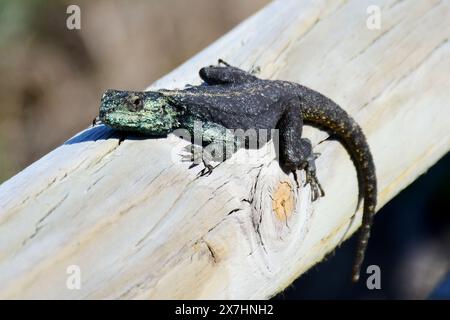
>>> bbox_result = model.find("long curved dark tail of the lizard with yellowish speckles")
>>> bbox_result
[302,96,377,282]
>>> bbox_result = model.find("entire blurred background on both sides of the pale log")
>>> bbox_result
[0,0,450,299]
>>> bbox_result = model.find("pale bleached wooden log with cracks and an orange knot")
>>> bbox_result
[0,0,450,299]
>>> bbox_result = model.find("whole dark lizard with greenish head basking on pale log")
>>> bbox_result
[99,59,377,282]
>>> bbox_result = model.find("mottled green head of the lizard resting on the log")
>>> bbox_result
[100,90,179,136]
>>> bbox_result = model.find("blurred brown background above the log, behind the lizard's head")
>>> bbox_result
[0,0,269,182]
